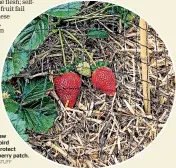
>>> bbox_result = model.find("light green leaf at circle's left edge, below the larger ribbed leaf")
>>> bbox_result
[2,51,29,81]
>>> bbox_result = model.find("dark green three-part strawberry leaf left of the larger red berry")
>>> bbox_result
[2,78,56,135]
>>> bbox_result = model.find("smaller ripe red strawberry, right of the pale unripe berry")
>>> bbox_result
[92,67,116,96]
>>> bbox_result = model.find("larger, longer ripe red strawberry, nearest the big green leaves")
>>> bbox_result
[54,72,81,108]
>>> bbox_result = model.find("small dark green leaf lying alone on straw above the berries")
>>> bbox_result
[88,28,109,39]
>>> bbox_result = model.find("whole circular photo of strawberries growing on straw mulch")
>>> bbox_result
[1,1,175,168]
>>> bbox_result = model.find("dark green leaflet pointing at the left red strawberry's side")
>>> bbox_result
[22,78,53,103]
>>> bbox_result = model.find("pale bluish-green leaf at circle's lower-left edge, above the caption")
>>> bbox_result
[7,112,29,141]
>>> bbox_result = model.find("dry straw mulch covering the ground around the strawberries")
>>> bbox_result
[2,1,175,167]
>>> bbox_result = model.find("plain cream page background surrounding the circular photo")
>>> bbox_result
[0,0,176,168]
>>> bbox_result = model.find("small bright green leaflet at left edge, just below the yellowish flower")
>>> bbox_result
[4,98,19,113]
